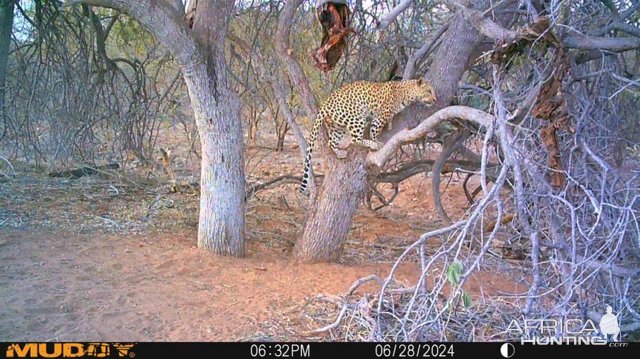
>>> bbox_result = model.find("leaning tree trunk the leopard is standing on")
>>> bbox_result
[294,14,481,262]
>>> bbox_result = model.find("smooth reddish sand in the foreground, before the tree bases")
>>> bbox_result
[0,230,523,341]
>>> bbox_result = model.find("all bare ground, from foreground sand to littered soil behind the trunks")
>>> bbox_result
[0,128,527,341]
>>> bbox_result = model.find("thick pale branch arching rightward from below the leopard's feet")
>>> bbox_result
[367,106,495,168]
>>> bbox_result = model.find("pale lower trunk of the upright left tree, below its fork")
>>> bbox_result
[184,60,245,257]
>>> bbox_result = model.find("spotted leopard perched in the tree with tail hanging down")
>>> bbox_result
[300,79,437,193]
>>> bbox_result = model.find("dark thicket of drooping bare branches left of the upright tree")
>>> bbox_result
[3,2,188,168]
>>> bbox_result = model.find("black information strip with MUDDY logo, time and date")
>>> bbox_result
[0,342,640,359]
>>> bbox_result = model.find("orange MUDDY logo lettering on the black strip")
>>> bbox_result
[6,343,135,358]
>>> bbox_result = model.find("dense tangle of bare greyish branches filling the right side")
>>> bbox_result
[323,1,640,341]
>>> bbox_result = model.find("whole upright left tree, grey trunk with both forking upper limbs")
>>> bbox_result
[78,0,245,257]
